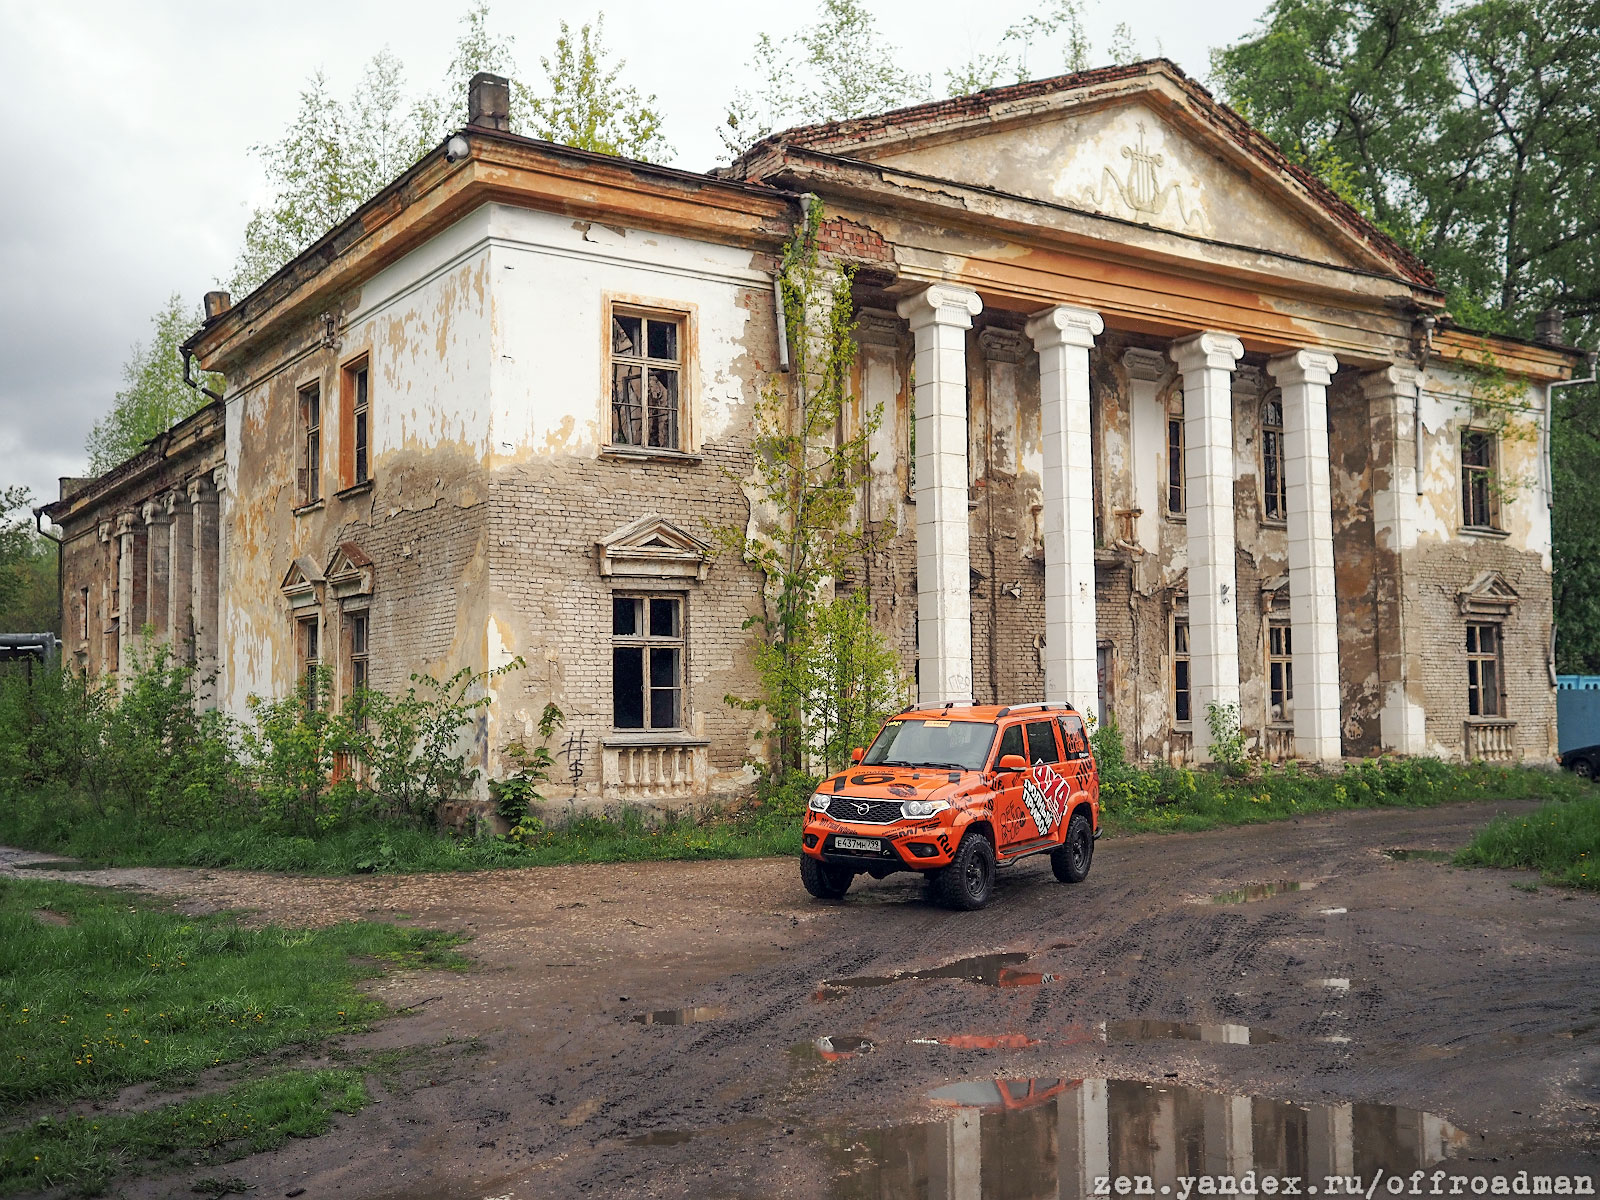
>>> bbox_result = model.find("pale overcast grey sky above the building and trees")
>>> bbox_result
[0,0,1266,512]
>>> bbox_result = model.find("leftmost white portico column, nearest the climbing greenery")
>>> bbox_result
[898,283,984,704]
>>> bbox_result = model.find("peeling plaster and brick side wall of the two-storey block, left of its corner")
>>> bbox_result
[222,210,491,715]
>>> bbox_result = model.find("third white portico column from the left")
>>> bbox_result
[1171,331,1245,762]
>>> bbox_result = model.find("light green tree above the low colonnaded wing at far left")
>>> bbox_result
[83,291,219,475]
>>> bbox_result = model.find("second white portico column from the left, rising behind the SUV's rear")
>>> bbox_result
[1027,304,1106,712]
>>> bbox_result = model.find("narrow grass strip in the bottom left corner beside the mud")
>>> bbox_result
[0,1070,370,1195]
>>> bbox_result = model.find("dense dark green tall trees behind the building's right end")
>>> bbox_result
[1213,0,1600,672]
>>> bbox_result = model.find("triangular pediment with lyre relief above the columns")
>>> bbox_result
[747,59,1432,285]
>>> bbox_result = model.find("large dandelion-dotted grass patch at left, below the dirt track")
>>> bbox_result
[0,878,466,1122]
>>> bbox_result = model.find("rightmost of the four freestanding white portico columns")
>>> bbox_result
[1267,350,1342,762]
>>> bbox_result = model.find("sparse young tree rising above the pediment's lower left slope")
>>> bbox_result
[722,0,930,155]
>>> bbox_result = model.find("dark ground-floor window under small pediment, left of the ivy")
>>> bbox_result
[611,595,683,730]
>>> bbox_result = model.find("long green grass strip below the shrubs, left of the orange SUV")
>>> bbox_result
[0,794,800,875]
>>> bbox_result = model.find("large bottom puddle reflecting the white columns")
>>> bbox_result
[826,1078,1467,1200]
